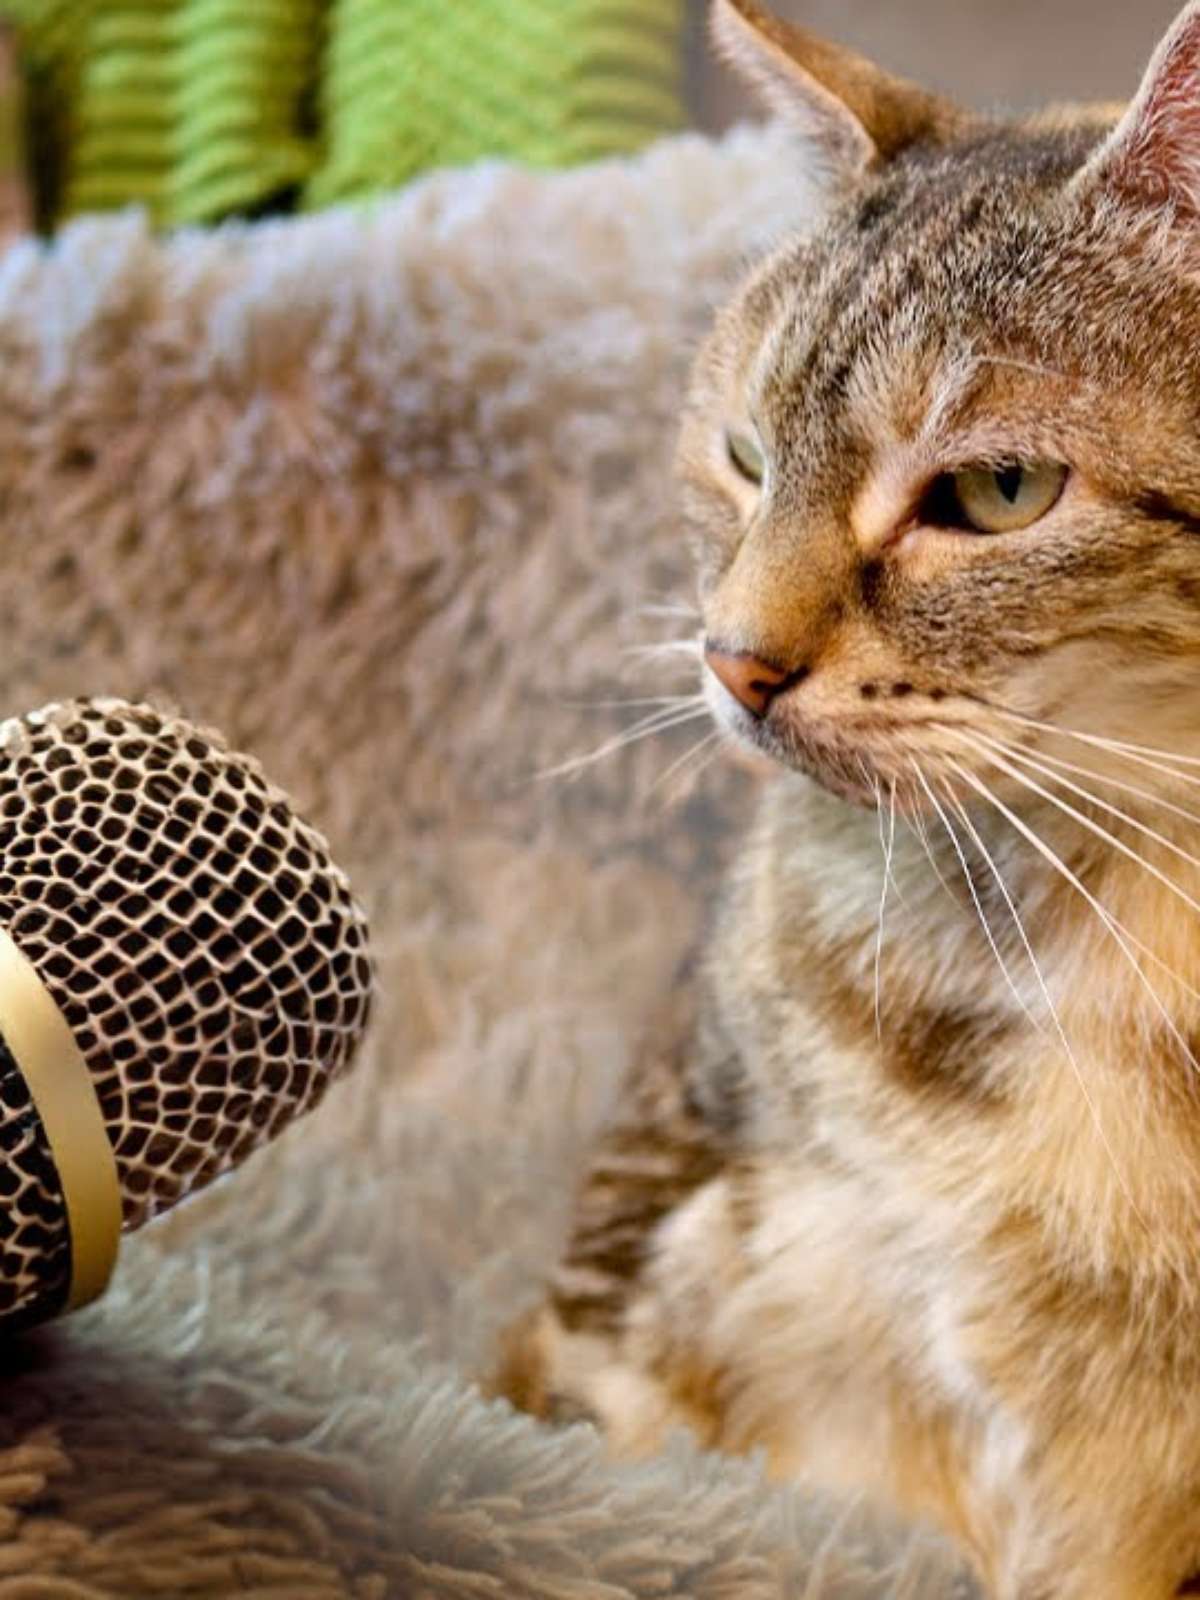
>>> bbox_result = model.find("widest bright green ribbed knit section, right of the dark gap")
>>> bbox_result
[306,0,683,205]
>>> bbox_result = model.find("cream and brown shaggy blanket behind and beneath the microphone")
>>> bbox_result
[0,131,979,1600]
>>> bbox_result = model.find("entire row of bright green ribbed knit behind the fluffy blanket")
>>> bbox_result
[3,0,683,224]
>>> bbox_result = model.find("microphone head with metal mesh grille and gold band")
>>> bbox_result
[0,699,373,1334]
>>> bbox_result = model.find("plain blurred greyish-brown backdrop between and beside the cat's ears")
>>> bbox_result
[686,0,1182,130]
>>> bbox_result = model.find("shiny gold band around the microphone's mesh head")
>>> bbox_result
[0,928,122,1310]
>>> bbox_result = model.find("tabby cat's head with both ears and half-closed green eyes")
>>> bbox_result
[680,0,1200,802]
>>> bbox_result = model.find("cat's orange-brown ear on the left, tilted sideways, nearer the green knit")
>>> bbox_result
[710,0,970,174]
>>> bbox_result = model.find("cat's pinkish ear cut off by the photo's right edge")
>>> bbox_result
[1075,0,1200,219]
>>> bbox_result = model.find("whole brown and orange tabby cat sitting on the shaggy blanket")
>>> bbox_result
[498,0,1200,1600]
